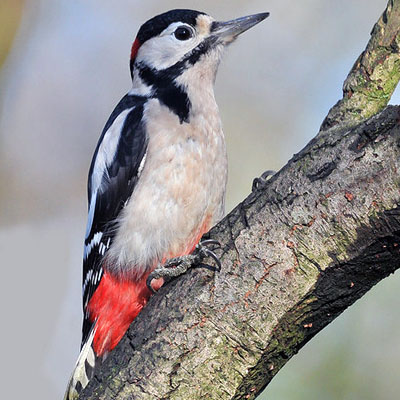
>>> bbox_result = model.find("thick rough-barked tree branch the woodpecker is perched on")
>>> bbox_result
[80,0,400,400]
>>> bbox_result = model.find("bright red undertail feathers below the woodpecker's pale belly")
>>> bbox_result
[88,272,156,356]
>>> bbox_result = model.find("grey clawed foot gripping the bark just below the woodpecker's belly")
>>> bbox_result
[146,239,221,293]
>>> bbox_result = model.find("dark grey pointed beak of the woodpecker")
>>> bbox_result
[211,13,269,43]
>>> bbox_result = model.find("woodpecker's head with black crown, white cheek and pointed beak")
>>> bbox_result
[130,10,269,83]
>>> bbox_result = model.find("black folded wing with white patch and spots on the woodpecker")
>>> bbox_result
[82,95,148,345]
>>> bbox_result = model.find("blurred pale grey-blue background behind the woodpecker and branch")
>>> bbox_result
[0,0,400,400]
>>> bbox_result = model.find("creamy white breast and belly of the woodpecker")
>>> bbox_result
[107,100,227,278]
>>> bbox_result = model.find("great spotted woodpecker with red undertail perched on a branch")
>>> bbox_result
[65,10,268,399]
